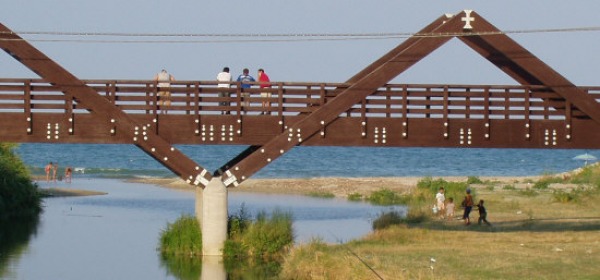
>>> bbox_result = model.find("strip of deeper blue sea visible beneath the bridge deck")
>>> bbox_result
[16,144,600,178]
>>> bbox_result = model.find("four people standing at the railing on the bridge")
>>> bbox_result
[154,67,271,114]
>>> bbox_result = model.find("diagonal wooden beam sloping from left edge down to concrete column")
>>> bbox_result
[0,24,212,186]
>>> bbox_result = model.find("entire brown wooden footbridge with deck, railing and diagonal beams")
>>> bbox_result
[0,11,600,190]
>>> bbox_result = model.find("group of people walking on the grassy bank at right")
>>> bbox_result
[433,187,491,226]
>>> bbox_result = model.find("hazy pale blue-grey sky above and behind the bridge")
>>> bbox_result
[0,0,600,86]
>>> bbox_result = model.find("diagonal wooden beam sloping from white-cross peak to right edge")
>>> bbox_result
[459,12,600,123]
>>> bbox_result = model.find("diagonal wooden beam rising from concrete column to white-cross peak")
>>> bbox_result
[222,12,463,186]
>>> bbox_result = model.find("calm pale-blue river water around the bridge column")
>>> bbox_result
[0,178,404,280]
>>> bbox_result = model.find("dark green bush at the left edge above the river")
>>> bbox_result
[0,143,42,219]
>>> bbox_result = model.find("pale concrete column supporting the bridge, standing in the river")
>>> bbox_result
[202,177,227,256]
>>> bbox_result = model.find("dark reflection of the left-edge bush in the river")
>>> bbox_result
[0,215,40,278]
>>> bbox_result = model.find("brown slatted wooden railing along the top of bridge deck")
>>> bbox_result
[0,79,600,120]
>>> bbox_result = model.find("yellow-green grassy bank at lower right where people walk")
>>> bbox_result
[281,172,600,279]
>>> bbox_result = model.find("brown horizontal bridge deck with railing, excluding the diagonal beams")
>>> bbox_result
[0,79,600,148]
